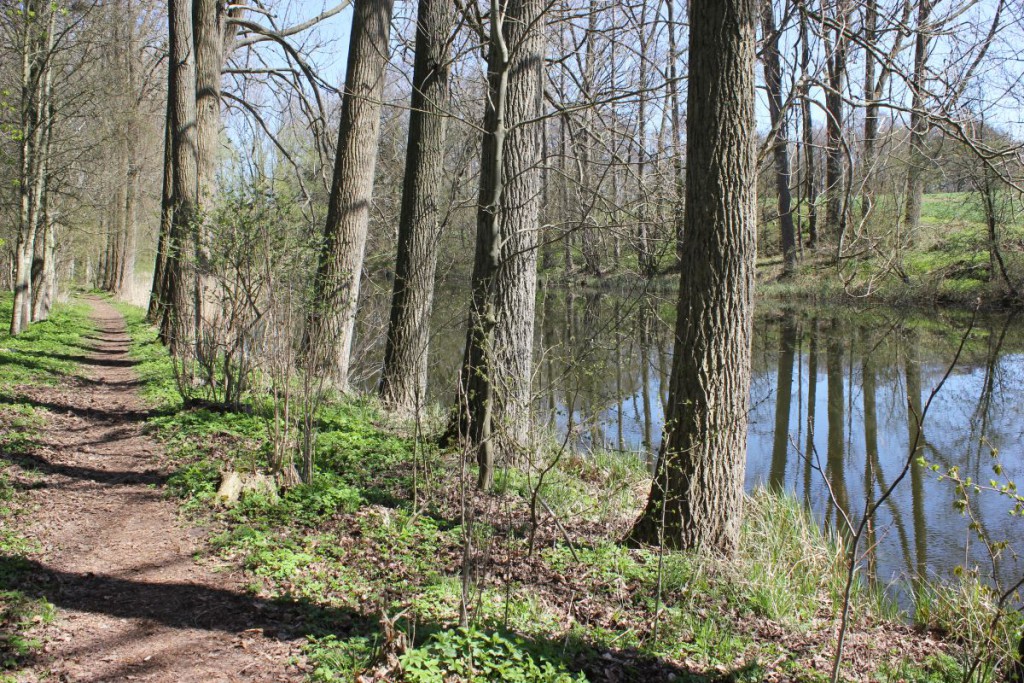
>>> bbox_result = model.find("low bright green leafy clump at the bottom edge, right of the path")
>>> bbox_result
[401,629,587,683]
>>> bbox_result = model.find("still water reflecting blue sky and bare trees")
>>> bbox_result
[352,291,1024,583]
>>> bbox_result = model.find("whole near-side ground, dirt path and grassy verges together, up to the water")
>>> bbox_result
[0,298,1017,683]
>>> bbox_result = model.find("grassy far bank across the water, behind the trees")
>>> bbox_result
[541,193,1024,310]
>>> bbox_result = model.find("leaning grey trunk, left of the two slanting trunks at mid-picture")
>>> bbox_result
[305,0,393,390]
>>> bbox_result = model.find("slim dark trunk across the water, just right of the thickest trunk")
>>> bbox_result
[761,0,797,275]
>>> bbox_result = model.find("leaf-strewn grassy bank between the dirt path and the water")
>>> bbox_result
[108,306,1013,683]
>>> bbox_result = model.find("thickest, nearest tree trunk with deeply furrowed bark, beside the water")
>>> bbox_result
[631,0,758,552]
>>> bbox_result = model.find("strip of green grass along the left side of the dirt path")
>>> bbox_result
[0,293,93,683]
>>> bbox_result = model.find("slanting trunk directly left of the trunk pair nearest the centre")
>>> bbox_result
[380,0,455,413]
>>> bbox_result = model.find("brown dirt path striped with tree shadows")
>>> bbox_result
[14,300,302,683]
